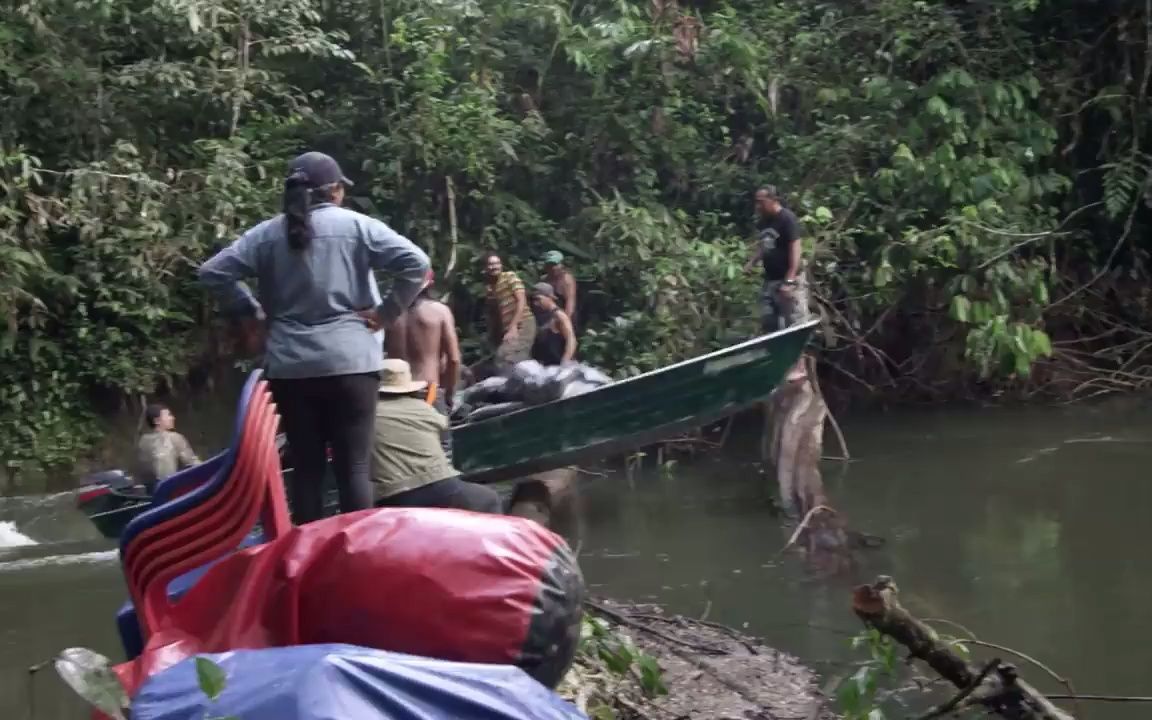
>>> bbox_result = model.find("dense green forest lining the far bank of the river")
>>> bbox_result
[0,0,1152,474]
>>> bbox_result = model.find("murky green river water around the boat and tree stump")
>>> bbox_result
[0,401,1152,720]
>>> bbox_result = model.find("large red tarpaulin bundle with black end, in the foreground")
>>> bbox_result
[108,508,584,697]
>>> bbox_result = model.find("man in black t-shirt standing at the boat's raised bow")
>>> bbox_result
[744,185,808,333]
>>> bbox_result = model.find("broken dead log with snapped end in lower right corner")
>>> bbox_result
[852,576,1075,720]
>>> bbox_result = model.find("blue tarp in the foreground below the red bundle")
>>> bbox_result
[131,645,586,720]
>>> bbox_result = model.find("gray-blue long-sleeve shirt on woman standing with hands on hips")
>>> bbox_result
[199,204,429,378]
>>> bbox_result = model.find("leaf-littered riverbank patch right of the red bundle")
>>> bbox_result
[560,599,835,720]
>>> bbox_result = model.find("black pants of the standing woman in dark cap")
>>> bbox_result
[270,372,380,524]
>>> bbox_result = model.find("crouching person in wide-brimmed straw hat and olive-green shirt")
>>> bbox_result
[372,357,503,514]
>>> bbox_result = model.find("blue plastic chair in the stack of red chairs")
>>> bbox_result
[116,370,274,660]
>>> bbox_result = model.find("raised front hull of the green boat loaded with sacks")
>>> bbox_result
[452,320,817,483]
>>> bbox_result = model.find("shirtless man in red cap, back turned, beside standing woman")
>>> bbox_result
[384,271,460,460]
